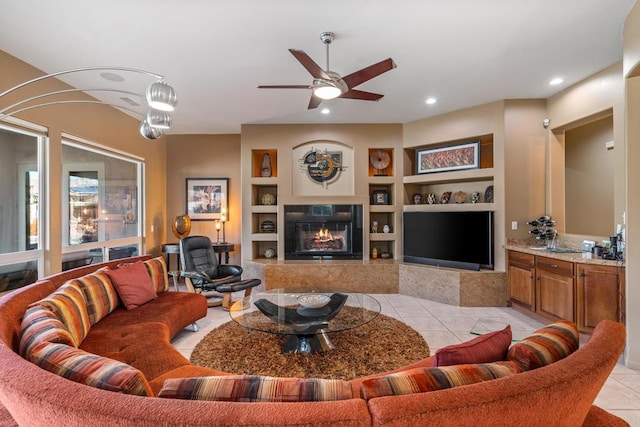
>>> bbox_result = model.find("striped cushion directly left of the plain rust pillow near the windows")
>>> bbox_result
[71,269,120,325]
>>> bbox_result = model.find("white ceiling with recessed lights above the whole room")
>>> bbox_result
[0,0,633,134]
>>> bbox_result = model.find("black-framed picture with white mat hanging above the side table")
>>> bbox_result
[185,178,229,221]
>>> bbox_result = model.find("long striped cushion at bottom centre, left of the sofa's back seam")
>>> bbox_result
[158,375,352,402]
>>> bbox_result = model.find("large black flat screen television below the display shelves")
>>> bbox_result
[402,211,493,270]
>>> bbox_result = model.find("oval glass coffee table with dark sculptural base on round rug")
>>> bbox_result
[229,289,380,354]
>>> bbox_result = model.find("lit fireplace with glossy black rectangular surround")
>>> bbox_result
[284,205,363,259]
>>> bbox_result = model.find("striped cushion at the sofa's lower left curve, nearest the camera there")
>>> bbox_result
[31,343,153,396]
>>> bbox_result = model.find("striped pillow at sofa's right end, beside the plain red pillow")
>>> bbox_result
[507,320,580,371]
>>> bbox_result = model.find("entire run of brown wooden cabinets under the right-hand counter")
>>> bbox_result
[507,250,625,333]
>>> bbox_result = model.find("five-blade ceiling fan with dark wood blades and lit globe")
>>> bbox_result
[258,31,396,110]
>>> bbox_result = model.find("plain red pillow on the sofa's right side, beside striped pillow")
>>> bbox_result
[435,325,512,366]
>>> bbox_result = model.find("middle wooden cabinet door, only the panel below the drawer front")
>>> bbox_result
[536,268,575,321]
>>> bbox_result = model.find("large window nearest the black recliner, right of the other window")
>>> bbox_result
[62,140,143,269]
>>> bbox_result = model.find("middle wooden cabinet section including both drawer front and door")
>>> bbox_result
[536,257,575,321]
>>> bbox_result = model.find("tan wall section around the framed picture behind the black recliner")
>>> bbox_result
[164,135,243,264]
